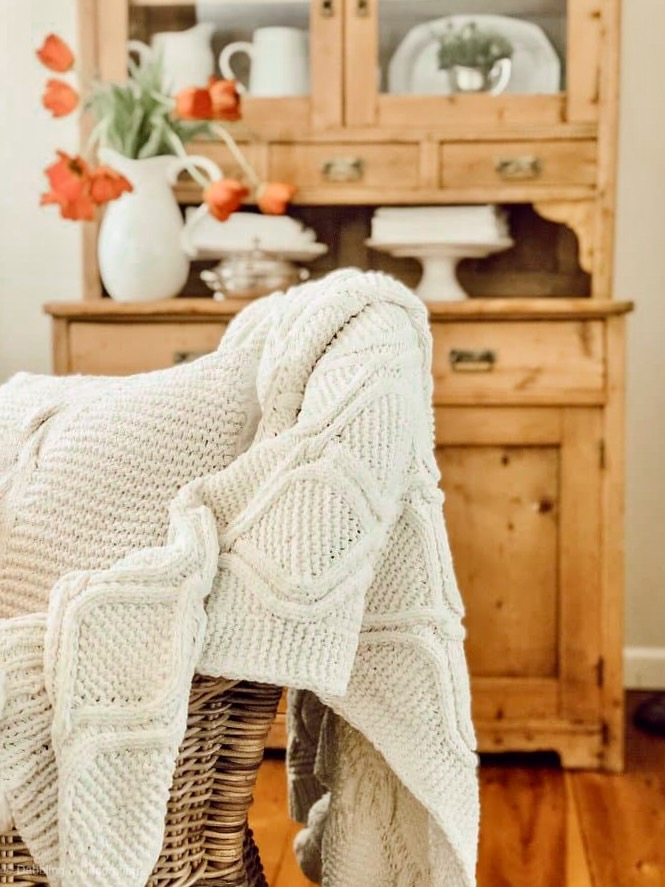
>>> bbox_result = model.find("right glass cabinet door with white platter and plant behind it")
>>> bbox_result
[346,0,614,126]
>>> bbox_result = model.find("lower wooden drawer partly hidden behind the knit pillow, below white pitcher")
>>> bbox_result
[68,322,227,376]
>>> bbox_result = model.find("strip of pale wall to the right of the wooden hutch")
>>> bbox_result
[615,0,665,688]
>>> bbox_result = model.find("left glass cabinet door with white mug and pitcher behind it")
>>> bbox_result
[97,0,342,135]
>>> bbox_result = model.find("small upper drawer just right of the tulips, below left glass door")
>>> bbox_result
[270,142,420,189]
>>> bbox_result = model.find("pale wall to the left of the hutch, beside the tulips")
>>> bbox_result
[0,0,82,380]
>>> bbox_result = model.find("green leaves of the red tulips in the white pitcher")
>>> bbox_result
[86,52,209,159]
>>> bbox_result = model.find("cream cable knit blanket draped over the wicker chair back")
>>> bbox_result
[0,271,478,887]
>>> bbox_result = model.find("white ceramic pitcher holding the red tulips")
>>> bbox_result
[97,148,221,302]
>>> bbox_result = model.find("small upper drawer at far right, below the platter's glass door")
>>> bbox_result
[441,141,597,188]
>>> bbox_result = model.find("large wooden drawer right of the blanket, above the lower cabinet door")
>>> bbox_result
[432,321,605,404]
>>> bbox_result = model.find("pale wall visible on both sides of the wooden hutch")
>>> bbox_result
[0,0,665,687]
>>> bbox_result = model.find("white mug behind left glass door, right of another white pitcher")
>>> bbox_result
[219,28,310,97]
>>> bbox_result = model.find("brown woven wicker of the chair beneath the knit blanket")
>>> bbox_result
[0,677,281,887]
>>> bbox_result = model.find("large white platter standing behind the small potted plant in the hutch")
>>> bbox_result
[388,15,561,95]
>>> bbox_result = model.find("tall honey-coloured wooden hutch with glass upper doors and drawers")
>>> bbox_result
[47,0,631,770]
